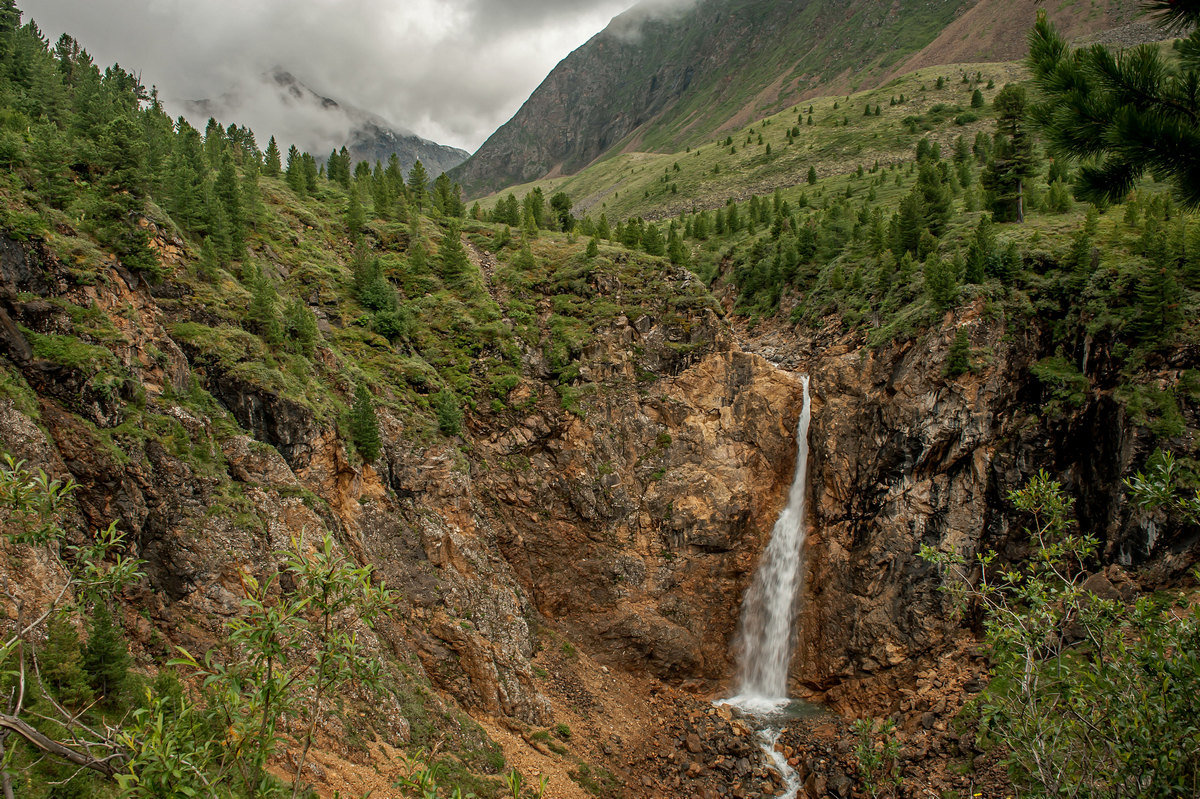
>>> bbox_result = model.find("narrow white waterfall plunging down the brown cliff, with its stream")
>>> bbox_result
[720,377,811,799]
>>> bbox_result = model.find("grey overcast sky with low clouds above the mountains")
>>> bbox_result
[18,0,635,151]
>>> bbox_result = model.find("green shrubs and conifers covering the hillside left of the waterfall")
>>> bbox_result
[0,0,700,797]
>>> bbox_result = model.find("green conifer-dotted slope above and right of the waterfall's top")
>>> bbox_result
[479,42,1200,438]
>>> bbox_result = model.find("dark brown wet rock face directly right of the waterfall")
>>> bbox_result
[745,310,1196,713]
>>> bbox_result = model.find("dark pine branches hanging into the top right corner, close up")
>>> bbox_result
[1030,0,1200,208]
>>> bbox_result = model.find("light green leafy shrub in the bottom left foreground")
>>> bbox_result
[164,527,395,798]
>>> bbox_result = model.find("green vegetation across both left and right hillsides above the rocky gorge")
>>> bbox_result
[0,0,1200,797]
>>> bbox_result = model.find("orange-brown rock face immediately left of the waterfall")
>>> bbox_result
[478,352,800,680]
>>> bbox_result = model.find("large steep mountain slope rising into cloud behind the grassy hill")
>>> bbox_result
[454,0,1120,194]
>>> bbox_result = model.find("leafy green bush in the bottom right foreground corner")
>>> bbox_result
[922,470,1200,798]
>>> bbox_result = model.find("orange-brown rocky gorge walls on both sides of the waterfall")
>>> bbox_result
[0,225,1195,797]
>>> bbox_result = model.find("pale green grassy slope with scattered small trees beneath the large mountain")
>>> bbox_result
[480,57,1028,220]
